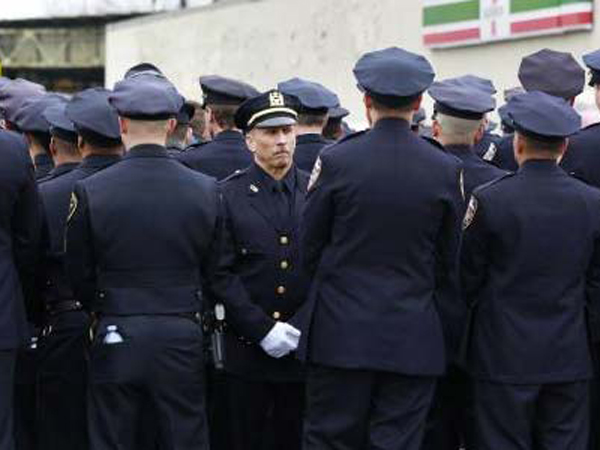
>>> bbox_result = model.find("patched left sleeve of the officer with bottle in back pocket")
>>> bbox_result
[65,183,97,310]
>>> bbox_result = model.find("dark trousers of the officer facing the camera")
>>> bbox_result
[227,375,304,450]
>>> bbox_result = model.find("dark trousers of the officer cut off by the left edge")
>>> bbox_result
[0,350,17,450]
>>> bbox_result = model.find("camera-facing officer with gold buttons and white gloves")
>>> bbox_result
[211,90,308,450]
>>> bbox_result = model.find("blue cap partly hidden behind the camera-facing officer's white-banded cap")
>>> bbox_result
[277,78,340,114]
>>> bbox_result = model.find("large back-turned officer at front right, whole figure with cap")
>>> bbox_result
[461,92,600,450]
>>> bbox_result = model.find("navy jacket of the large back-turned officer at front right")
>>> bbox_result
[461,160,600,384]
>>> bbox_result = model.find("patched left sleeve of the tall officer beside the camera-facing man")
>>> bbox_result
[301,154,335,279]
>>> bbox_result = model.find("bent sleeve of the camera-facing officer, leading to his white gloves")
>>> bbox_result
[207,189,275,343]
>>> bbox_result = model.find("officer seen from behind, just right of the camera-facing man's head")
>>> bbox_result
[278,78,340,172]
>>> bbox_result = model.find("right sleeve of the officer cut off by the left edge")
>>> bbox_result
[11,162,42,320]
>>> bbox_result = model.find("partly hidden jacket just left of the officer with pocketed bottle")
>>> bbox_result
[39,155,120,312]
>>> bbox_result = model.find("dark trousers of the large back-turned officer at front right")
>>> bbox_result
[474,381,590,450]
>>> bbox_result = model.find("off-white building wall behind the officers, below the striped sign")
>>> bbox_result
[106,0,600,123]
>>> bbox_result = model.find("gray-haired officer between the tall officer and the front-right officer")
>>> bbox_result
[422,77,505,450]
